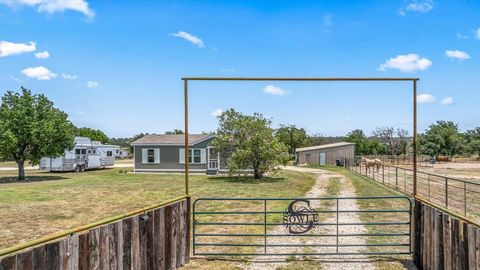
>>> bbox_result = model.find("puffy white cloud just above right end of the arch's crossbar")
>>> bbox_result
[378,53,432,72]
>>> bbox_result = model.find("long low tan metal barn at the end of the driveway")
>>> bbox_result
[296,142,355,166]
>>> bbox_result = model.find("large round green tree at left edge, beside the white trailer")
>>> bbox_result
[0,87,74,180]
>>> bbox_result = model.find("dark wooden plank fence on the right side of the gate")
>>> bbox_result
[414,199,480,269]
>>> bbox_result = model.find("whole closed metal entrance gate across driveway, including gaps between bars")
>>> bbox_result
[193,196,412,256]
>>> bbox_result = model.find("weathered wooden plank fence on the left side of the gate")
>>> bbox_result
[0,198,190,270]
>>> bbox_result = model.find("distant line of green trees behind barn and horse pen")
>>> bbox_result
[275,121,480,159]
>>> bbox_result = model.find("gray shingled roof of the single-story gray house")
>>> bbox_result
[132,134,214,145]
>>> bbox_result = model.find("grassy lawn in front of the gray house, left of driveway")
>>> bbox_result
[0,169,315,248]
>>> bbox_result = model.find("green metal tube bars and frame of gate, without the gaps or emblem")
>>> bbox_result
[193,196,413,256]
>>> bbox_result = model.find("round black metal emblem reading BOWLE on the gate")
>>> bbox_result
[283,199,318,234]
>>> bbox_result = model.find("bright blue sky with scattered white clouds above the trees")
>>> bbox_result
[0,0,480,137]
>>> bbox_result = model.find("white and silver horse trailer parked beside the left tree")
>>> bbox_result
[40,137,120,172]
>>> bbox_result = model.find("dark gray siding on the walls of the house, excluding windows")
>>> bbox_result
[134,138,224,171]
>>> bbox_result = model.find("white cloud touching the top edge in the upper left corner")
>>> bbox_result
[0,0,95,18]
